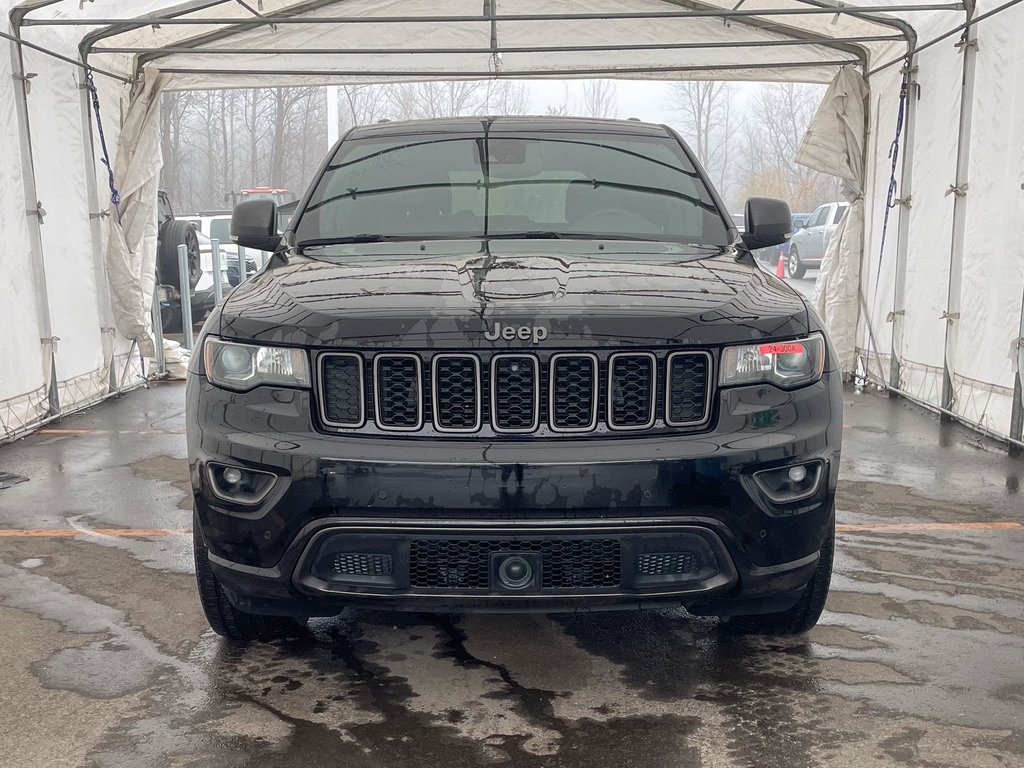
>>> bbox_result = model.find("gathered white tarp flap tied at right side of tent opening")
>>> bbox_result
[797,67,867,371]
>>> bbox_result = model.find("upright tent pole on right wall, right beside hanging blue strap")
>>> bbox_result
[889,53,920,388]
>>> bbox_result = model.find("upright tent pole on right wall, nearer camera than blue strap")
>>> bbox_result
[942,0,978,418]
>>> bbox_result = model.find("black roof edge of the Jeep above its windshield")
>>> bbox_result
[345,115,671,138]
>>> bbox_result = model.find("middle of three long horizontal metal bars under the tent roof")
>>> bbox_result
[89,35,904,60]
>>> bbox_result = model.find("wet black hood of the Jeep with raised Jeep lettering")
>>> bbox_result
[220,241,811,348]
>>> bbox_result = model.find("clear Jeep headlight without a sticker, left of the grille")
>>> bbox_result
[203,336,309,391]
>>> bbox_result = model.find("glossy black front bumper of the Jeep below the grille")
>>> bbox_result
[187,374,842,615]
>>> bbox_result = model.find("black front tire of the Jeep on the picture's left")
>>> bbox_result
[193,515,305,643]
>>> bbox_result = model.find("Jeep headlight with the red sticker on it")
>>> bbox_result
[719,334,825,389]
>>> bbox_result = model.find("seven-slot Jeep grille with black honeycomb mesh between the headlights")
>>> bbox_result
[317,350,714,437]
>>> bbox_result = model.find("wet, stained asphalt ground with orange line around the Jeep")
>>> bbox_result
[0,384,1024,768]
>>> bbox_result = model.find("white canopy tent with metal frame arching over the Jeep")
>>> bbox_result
[0,0,1024,448]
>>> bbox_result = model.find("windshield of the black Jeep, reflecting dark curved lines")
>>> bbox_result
[296,132,728,247]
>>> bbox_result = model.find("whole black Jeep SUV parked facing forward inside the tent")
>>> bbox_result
[187,118,842,640]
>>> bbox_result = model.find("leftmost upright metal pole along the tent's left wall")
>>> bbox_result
[10,22,60,417]
